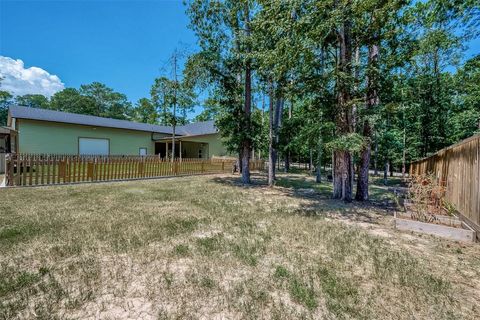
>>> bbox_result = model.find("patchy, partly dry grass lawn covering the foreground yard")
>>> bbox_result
[0,174,480,319]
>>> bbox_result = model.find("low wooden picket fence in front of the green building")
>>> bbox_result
[6,154,264,186]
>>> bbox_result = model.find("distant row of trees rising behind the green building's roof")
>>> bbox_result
[0,70,196,125]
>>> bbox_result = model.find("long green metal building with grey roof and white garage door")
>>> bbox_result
[8,106,227,159]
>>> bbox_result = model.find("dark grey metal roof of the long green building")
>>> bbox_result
[9,106,217,135]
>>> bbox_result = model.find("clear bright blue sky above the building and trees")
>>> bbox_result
[0,0,480,112]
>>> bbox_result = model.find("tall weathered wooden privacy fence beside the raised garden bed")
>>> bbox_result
[410,135,480,231]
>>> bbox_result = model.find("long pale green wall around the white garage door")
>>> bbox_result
[17,119,159,155]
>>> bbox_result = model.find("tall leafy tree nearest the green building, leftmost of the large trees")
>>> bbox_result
[187,0,257,184]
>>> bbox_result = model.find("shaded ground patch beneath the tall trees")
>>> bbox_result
[212,173,397,224]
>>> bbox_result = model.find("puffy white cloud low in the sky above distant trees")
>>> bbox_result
[0,56,65,97]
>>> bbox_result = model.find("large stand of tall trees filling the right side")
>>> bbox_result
[185,0,480,201]
